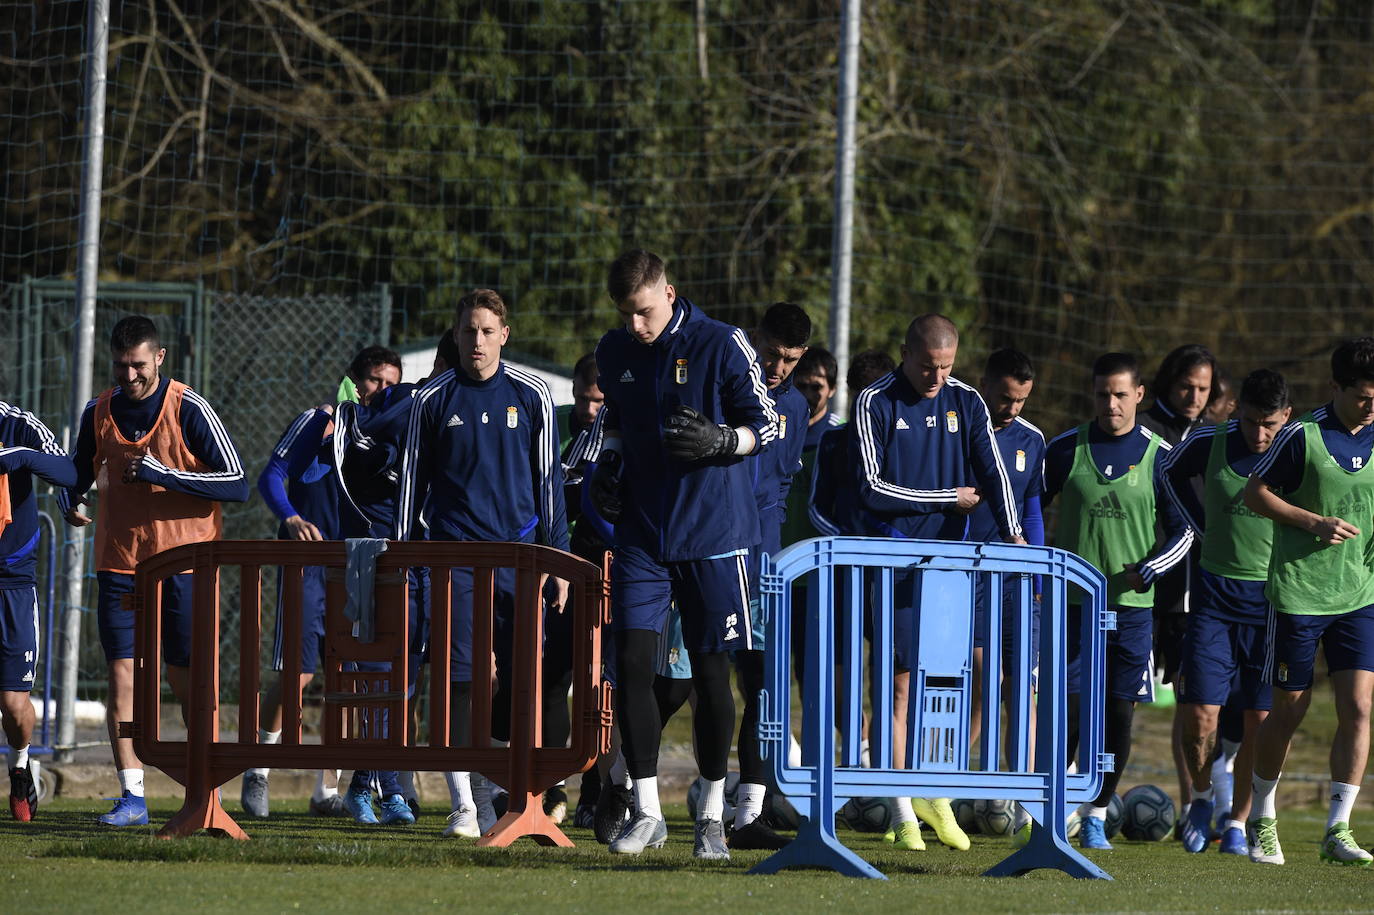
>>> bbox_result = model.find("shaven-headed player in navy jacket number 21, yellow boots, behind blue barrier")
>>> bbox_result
[851,315,1025,850]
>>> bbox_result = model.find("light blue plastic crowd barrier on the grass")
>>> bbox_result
[750,537,1116,879]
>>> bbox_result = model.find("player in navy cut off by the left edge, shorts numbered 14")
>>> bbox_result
[0,403,77,820]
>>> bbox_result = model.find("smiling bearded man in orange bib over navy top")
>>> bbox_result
[59,315,249,826]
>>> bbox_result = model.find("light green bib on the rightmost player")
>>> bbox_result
[1264,418,1374,615]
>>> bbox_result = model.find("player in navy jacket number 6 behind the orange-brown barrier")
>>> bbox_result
[397,289,569,837]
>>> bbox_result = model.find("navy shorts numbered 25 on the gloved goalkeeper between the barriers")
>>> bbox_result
[610,547,763,653]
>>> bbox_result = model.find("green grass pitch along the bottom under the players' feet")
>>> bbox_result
[8,801,1374,915]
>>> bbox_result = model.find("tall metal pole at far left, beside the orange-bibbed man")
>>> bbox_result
[58,0,110,761]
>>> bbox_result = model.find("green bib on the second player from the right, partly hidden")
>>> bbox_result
[1202,423,1274,581]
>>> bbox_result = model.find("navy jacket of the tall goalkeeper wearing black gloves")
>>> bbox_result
[581,298,778,562]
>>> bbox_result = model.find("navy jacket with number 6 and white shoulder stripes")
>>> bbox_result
[396,363,567,550]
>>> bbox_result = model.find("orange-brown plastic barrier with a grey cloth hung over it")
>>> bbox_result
[120,540,610,846]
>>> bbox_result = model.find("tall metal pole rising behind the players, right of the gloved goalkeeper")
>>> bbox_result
[830,0,860,416]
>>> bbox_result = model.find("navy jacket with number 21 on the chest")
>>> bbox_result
[851,367,1021,540]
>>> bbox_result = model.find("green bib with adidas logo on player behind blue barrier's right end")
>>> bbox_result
[1055,423,1160,607]
